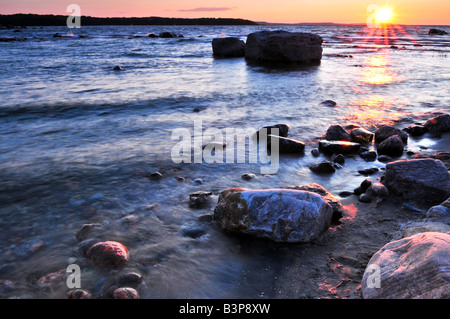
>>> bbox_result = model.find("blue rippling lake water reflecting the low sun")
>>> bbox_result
[0,25,450,298]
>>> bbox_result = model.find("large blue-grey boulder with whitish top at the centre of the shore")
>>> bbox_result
[214,188,333,243]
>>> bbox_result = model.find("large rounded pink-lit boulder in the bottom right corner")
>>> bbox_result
[361,232,450,299]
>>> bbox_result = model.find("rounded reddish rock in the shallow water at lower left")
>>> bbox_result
[86,241,129,269]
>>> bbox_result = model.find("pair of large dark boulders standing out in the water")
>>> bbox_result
[212,30,323,63]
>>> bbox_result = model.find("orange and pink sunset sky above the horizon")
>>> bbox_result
[0,0,450,25]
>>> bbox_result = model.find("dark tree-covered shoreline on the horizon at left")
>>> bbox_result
[0,14,257,26]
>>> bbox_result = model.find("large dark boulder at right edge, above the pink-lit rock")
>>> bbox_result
[383,159,450,203]
